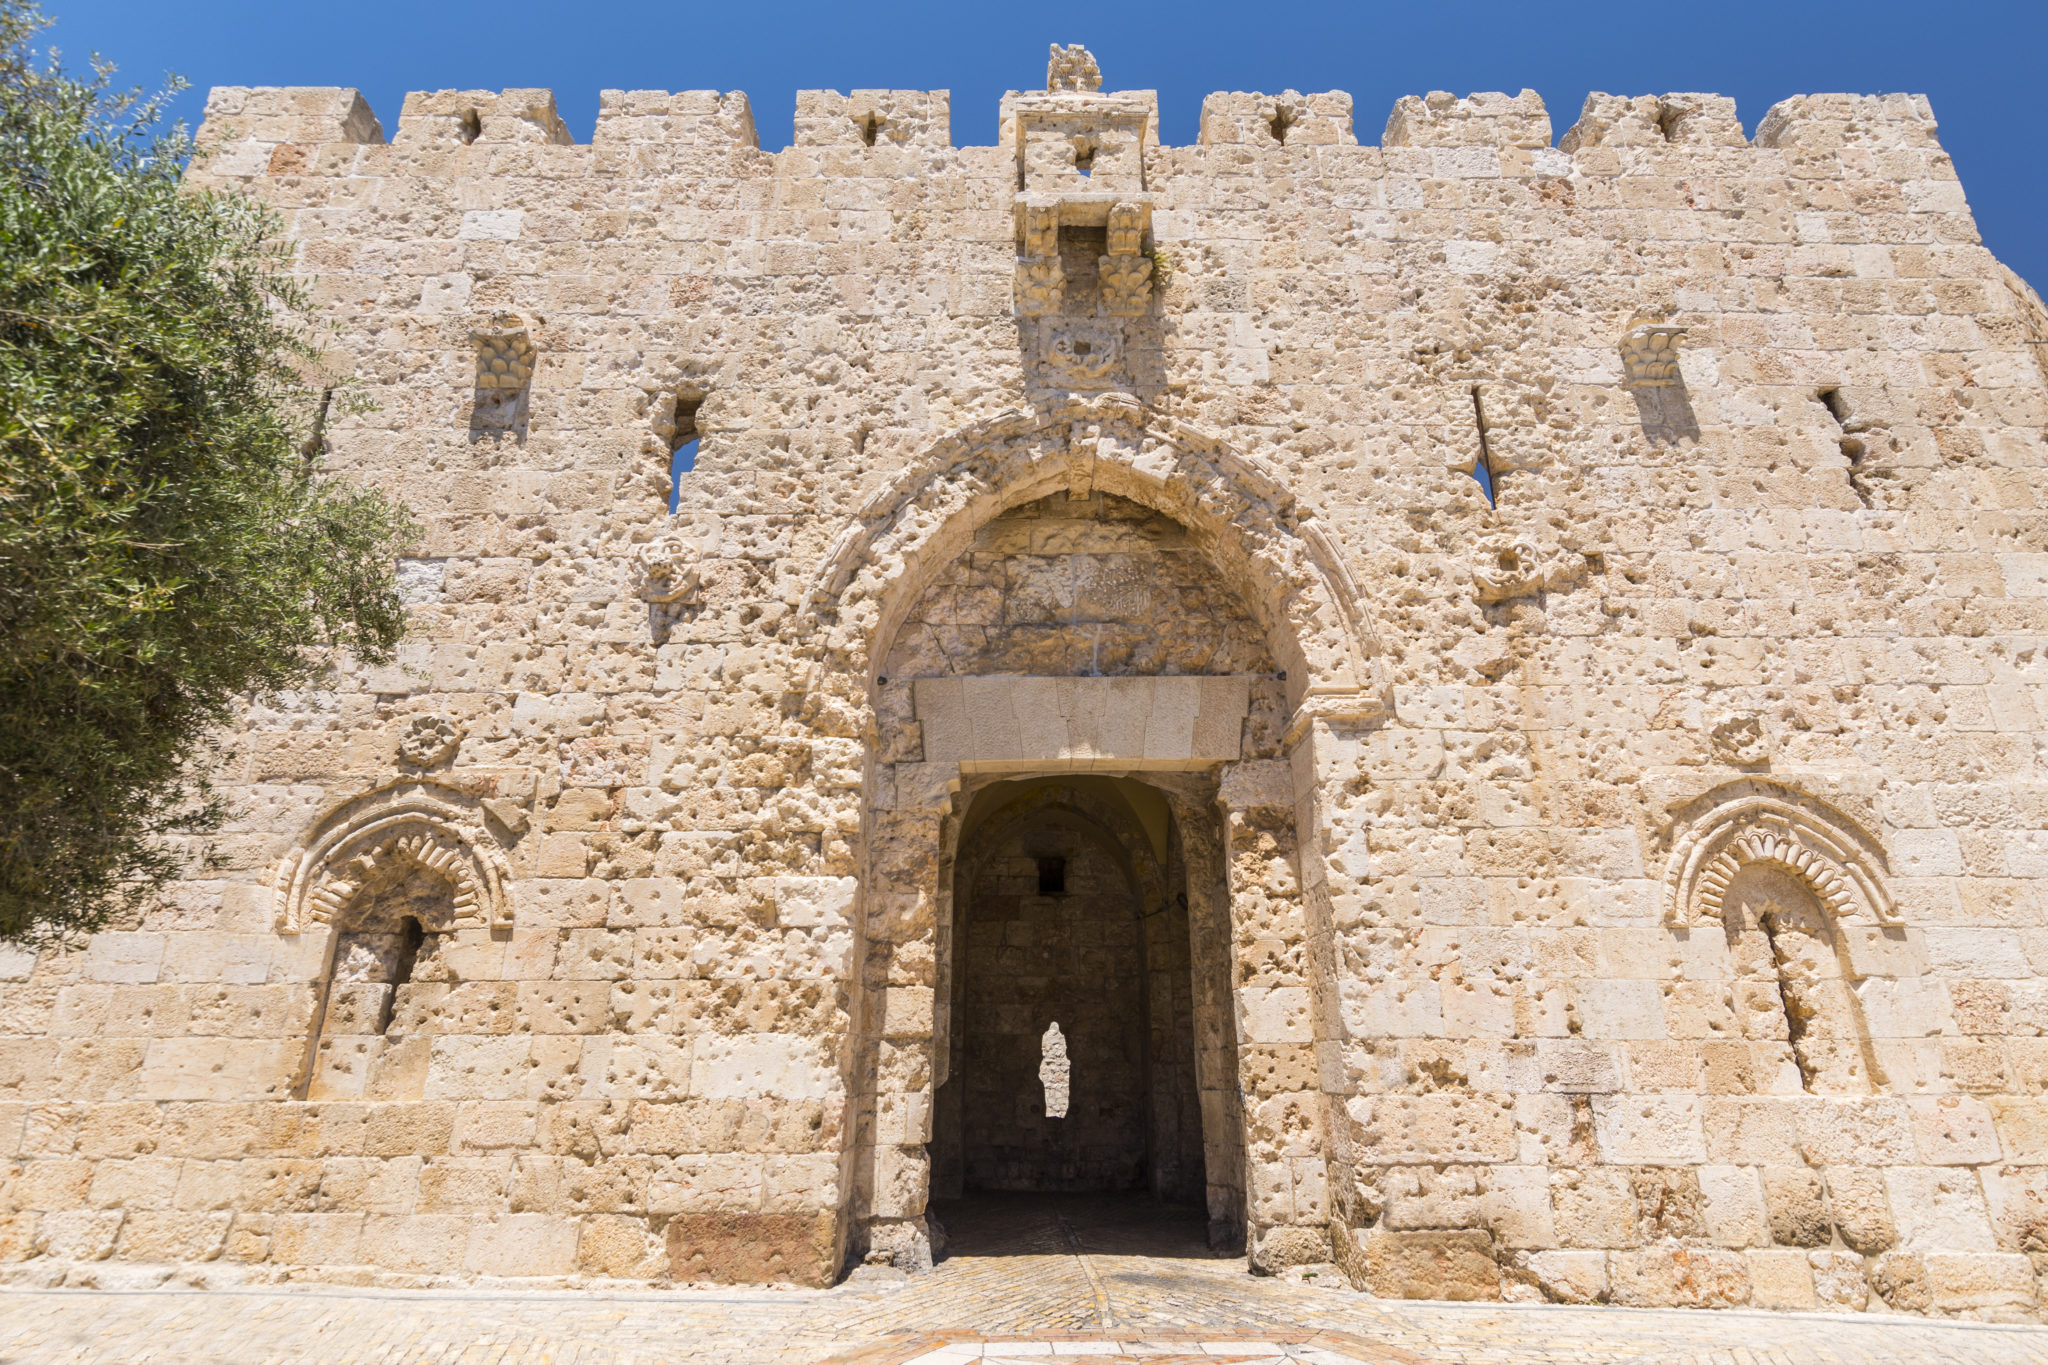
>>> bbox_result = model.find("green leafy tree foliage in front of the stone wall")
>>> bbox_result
[0,0,412,943]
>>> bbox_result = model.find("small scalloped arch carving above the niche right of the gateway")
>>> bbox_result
[1663,784,1901,927]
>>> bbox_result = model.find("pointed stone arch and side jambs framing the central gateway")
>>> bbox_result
[823,393,1391,1271]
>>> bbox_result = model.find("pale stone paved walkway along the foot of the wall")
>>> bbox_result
[0,1199,2048,1365]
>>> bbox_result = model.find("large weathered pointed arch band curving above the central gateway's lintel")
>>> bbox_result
[797,393,1386,712]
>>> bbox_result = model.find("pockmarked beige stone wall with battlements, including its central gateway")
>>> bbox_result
[0,47,2048,1326]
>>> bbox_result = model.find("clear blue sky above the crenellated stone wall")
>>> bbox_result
[45,0,2048,291]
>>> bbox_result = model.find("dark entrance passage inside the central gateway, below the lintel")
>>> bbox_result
[932,778,1206,1232]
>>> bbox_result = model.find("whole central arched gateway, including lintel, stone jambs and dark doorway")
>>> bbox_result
[805,393,1384,1265]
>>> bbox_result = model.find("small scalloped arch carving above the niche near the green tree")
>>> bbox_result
[270,782,512,933]
